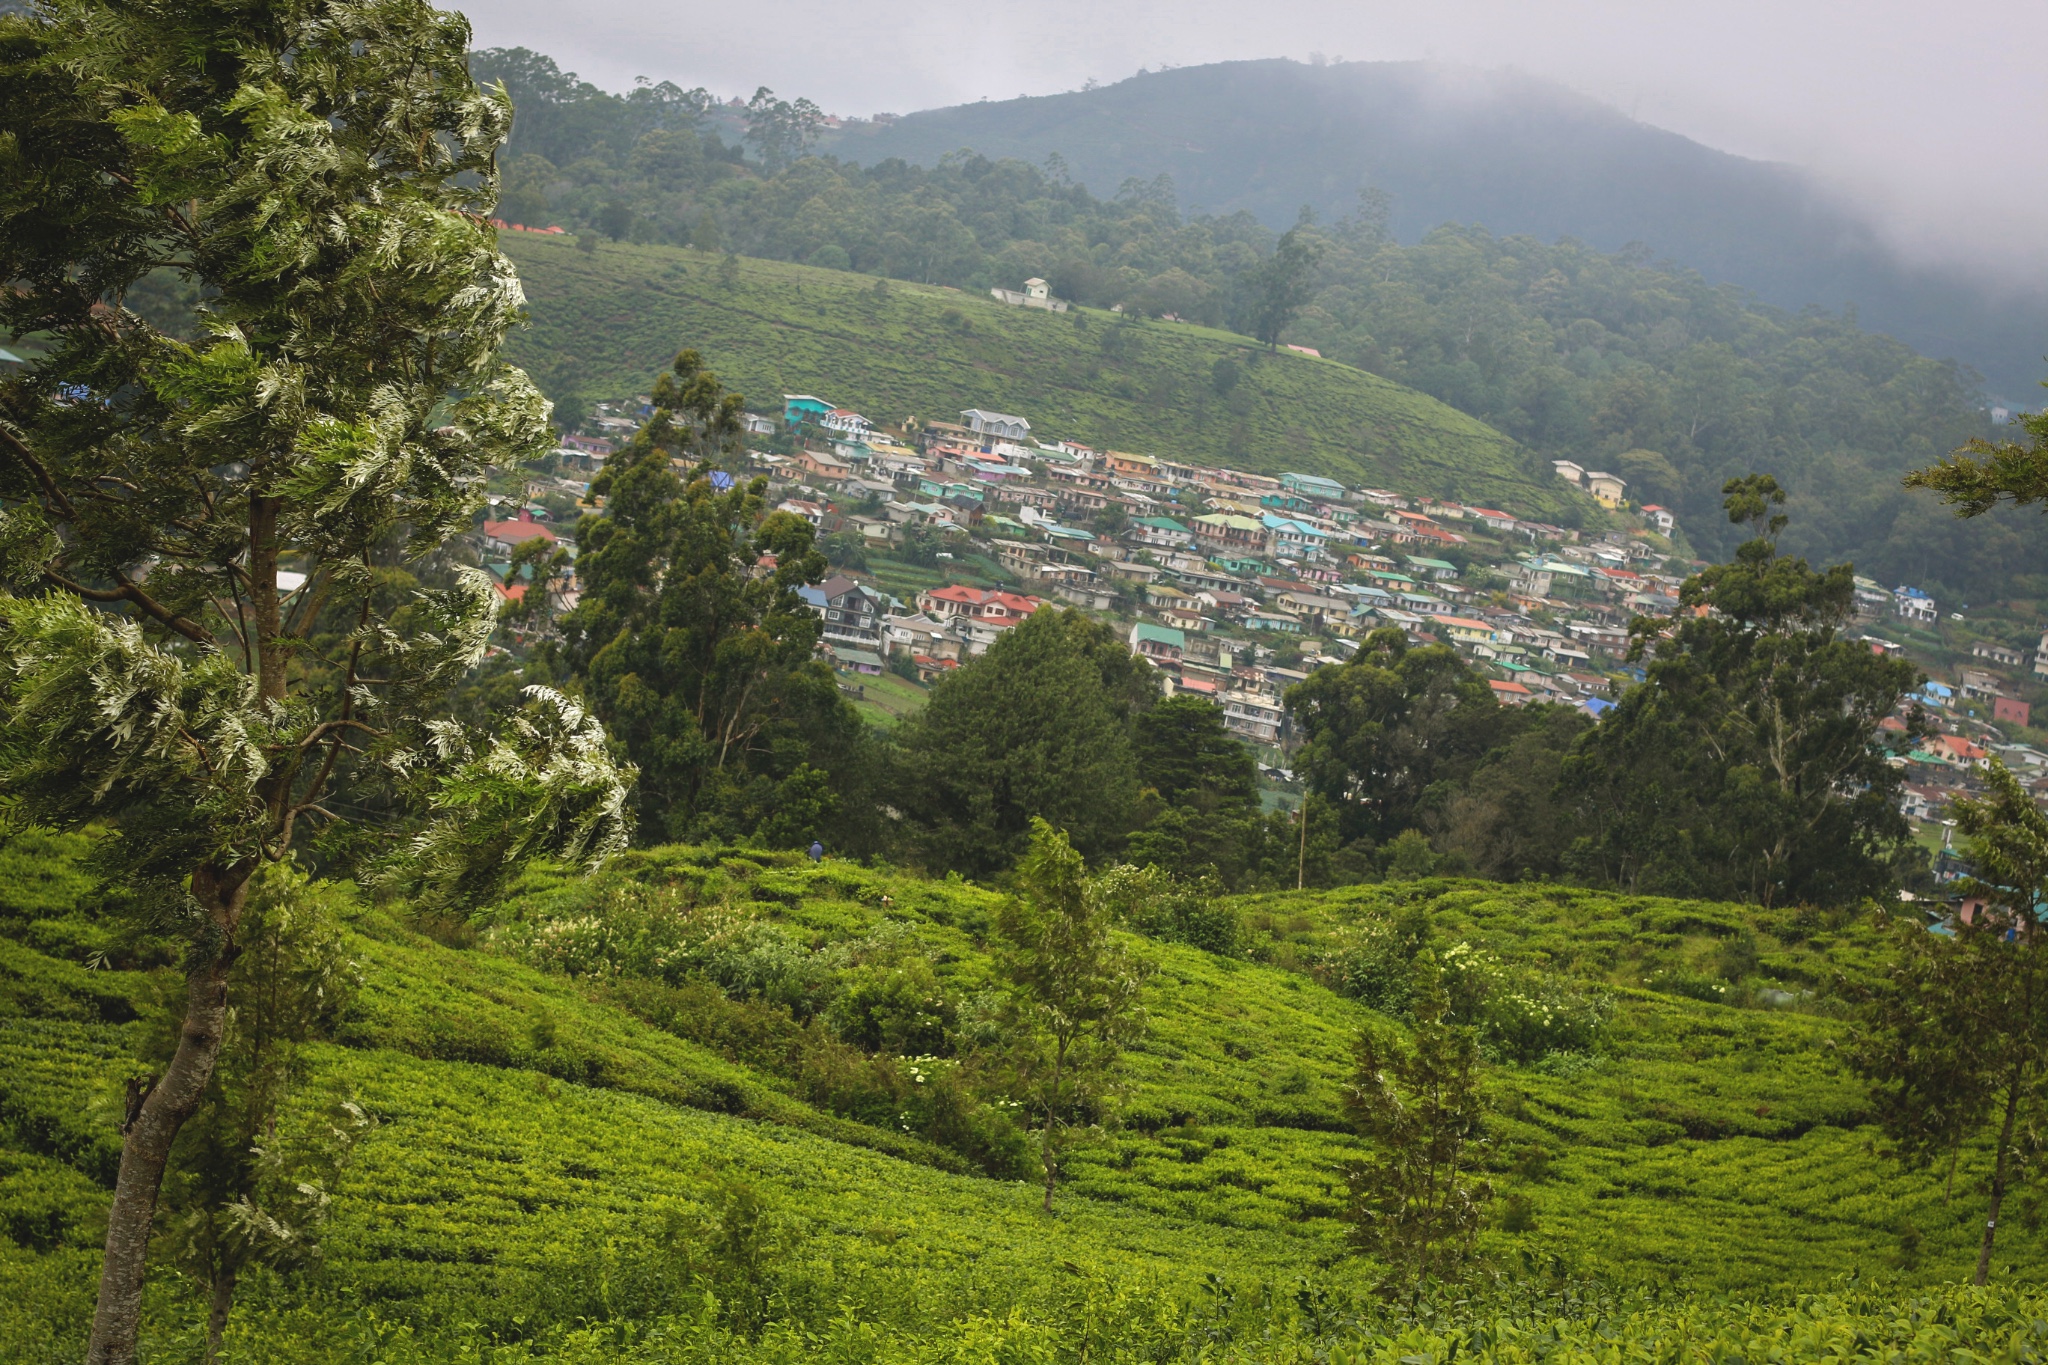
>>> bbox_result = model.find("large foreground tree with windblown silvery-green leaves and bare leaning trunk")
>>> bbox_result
[0,0,629,1363]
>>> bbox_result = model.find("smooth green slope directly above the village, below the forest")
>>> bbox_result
[502,233,1563,516]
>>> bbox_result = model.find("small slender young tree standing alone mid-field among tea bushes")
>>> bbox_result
[995,819,1145,1214]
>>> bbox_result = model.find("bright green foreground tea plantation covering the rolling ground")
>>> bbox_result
[0,837,2048,1365]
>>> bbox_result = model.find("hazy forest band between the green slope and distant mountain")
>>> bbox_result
[473,51,2048,600]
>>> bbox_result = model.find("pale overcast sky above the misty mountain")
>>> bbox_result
[461,0,2048,287]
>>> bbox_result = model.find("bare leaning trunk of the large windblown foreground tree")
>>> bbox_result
[86,952,231,1365]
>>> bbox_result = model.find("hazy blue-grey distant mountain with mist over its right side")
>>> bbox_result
[827,59,2048,403]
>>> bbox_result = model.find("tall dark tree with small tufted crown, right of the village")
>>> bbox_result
[1565,475,1919,905]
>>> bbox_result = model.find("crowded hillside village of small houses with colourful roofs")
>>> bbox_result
[475,378,2048,849]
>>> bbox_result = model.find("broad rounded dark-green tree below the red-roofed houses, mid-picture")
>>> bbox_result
[891,608,1157,876]
